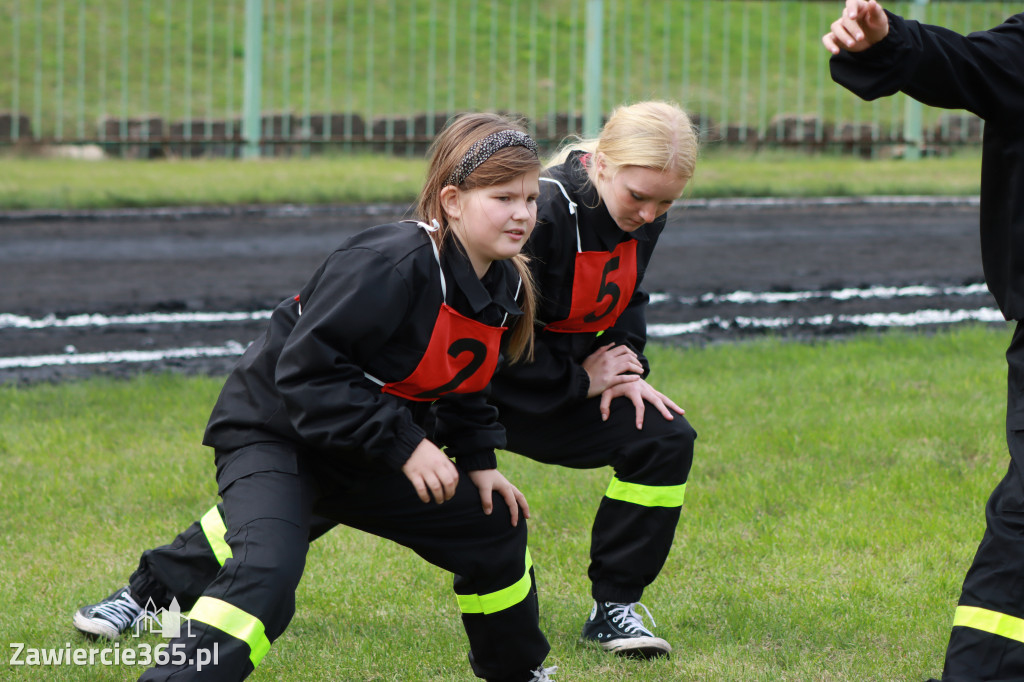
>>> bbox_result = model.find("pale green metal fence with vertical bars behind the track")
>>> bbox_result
[0,0,1007,156]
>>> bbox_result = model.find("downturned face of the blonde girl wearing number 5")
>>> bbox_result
[594,158,687,232]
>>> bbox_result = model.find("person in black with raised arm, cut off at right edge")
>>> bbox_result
[822,0,1024,682]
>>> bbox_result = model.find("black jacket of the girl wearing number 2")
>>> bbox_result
[204,222,521,470]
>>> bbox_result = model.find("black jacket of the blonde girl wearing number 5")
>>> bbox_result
[492,152,667,415]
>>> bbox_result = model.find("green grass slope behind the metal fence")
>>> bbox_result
[0,0,1010,139]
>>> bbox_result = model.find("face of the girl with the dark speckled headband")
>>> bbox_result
[441,171,541,278]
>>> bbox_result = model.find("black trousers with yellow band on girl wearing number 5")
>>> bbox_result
[499,396,696,602]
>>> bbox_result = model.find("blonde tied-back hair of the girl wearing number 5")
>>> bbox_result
[548,99,698,187]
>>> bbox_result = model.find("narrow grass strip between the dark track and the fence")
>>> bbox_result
[0,150,980,210]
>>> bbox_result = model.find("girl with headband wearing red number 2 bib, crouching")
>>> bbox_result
[74,114,554,682]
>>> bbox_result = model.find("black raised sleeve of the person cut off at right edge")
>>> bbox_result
[829,11,1024,120]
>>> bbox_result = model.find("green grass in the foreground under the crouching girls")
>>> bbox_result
[0,326,1010,682]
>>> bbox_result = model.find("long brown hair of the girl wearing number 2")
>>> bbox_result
[416,114,541,363]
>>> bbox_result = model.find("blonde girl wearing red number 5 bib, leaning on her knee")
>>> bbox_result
[492,101,697,657]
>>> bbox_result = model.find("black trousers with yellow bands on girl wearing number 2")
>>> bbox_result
[130,443,550,682]
